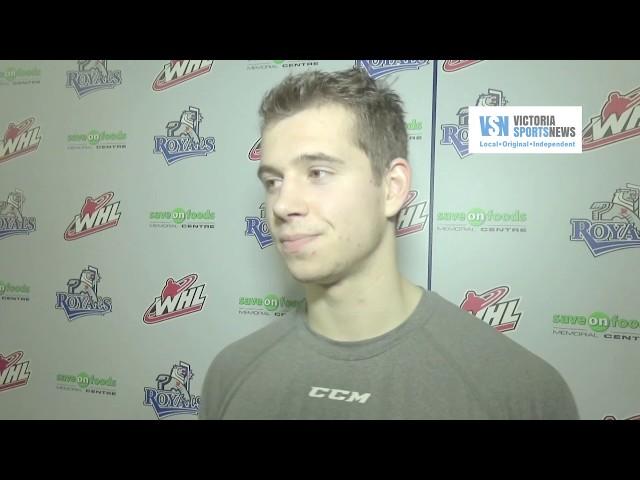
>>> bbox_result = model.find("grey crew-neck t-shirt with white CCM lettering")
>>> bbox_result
[199,289,578,419]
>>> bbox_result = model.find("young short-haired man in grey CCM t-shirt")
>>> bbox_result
[200,69,577,419]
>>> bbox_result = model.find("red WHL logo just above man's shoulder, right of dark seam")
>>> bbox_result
[460,286,522,332]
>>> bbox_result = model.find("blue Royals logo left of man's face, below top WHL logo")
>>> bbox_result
[153,106,216,165]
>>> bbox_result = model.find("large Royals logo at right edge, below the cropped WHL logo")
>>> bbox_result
[569,183,640,257]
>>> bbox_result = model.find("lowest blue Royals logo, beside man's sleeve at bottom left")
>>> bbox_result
[142,361,200,420]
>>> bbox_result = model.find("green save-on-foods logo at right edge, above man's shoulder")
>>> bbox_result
[553,311,640,343]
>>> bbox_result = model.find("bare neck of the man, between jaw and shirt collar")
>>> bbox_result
[306,251,422,342]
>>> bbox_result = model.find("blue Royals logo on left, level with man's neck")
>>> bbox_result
[56,265,112,321]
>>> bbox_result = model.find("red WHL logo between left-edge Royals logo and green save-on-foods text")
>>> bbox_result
[64,192,120,240]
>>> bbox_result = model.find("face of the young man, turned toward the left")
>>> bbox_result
[259,105,387,285]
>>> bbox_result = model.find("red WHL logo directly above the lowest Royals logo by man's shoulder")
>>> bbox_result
[142,273,207,324]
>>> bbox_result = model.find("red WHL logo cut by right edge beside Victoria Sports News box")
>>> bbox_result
[582,87,640,152]
